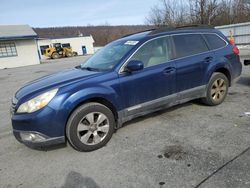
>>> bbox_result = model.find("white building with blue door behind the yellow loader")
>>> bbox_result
[37,35,95,59]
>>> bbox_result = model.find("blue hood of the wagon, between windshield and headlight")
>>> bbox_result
[15,68,98,100]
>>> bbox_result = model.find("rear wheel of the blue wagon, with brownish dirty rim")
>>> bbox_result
[201,72,229,106]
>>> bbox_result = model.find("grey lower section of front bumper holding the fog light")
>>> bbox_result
[13,130,65,147]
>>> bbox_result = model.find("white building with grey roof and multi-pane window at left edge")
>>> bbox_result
[0,25,40,69]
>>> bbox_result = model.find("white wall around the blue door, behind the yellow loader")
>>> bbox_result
[38,36,95,59]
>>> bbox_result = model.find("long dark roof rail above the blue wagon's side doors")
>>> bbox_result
[148,25,214,35]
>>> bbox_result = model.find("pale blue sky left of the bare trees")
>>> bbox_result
[0,0,159,27]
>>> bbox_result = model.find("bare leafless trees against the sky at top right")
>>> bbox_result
[146,0,250,26]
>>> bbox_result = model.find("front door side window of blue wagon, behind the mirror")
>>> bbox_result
[130,37,172,67]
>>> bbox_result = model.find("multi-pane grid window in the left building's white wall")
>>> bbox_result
[0,42,17,57]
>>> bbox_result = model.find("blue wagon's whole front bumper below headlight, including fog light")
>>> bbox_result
[11,106,65,146]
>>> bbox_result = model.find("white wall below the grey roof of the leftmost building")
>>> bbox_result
[0,39,40,69]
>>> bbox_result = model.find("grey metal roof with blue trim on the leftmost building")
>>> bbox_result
[0,25,37,40]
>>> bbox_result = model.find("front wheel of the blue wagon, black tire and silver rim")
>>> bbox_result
[66,102,116,152]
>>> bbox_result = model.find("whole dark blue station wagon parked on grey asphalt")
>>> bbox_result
[11,26,242,151]
